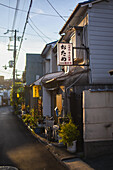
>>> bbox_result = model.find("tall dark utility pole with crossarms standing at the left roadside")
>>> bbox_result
[13,30,17,110]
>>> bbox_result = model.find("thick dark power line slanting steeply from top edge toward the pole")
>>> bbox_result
[17,0,32,58]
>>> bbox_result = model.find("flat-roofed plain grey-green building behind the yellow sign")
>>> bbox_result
[24,54,43,107]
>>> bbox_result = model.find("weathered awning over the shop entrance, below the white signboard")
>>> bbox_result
[31,67,89,90]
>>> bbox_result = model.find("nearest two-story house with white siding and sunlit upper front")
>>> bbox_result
[40,0,113,155]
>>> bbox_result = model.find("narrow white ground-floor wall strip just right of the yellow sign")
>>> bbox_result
[43,87,51,117]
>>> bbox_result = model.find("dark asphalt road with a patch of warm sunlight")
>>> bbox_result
[0,107,66,170]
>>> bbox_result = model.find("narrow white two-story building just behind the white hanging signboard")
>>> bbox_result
[41,41,62,117]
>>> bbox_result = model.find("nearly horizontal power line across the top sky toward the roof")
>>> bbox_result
[0,3,69,18]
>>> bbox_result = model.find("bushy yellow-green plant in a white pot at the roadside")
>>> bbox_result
[59,119,80,153]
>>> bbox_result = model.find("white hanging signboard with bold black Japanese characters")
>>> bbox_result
[57,43,73,66]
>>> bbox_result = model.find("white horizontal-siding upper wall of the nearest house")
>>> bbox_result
[88,0,113,84]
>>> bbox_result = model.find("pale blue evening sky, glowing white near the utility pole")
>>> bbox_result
[0,0,84,79]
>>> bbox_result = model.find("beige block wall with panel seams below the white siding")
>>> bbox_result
[83,91,113,142]
